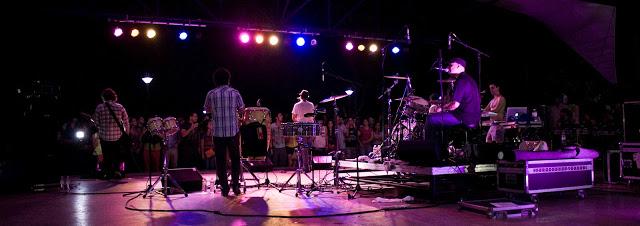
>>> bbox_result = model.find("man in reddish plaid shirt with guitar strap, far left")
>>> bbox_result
[93,88,129,178]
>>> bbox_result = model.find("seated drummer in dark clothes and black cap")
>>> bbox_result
[426,58,481,160]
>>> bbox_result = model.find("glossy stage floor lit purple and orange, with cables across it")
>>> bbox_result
[0,171,640,225]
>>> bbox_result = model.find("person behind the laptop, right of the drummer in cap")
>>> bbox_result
[483,82,507,143]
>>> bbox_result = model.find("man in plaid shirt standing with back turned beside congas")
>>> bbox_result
[204,68,244,196]
